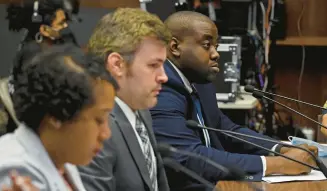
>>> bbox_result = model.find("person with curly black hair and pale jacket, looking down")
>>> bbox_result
[0,46,117,191]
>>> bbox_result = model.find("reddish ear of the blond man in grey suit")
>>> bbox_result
[106,52,125,77]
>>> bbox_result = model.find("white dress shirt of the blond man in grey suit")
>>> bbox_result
[115,97,157,172]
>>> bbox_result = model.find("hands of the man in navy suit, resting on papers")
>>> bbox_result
[266,145,318,175]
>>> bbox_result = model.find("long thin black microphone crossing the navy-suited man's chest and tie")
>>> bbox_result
[186,120,327,173]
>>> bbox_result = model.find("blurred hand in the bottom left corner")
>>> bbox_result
[1,172,39,191]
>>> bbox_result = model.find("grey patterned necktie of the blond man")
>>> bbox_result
[135,113,158,191]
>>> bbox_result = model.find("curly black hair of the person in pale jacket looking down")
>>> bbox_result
[13,45,118,132]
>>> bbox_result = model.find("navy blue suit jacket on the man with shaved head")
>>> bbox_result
[150,62,274,190]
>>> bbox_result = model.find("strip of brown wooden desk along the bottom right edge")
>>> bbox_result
[217,180,327,191]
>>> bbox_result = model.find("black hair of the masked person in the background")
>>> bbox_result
[6,0,80,39]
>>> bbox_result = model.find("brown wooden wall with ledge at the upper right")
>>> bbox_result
[271,0,327,134]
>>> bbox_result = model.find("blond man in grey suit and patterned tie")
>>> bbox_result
[79,8,171,191]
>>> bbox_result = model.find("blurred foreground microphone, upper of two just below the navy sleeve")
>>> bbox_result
[157,143,245,180]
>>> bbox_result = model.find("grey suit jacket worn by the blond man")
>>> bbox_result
[79,104,169,191]
